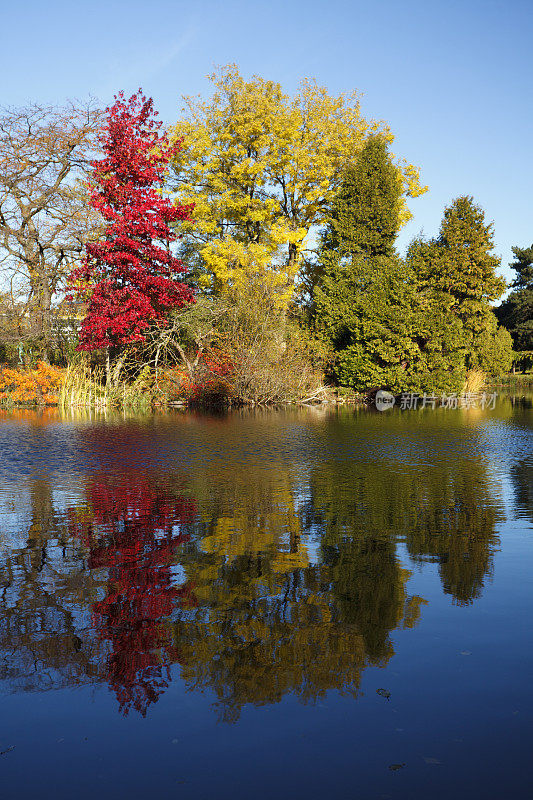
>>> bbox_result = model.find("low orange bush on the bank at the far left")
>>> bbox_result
[0,361,65,405]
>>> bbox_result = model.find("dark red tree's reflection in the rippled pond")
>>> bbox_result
[70,476,195,716]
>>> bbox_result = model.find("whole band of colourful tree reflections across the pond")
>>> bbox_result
[0,410,512,721]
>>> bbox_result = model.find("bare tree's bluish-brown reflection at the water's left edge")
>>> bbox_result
[0,479,99,690]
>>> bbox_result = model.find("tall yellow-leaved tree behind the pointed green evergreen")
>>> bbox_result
[171,65,426,308]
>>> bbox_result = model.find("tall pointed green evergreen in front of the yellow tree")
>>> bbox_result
[313,136,408,387]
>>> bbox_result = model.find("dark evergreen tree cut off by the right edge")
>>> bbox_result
[496,244,533,351]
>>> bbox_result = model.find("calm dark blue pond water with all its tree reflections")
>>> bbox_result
[0,398,533,800]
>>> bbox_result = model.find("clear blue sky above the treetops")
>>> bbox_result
[0,0,533,277]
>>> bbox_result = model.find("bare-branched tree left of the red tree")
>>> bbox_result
[0,103,101,355]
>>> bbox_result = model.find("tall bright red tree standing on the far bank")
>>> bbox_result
[71,89,194,350]
